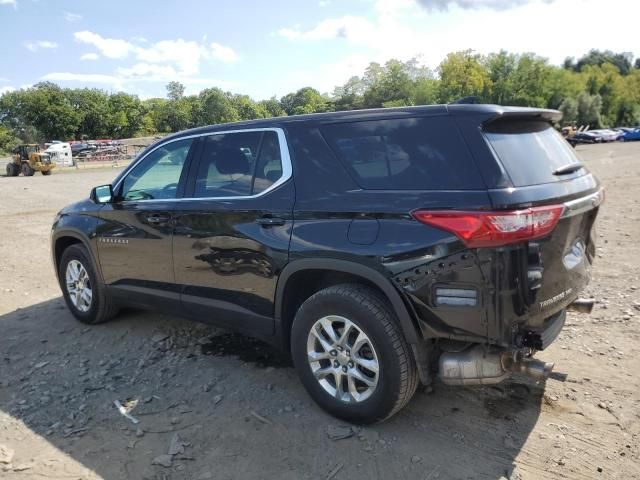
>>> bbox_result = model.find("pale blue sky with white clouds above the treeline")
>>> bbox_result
[0,0,640,100]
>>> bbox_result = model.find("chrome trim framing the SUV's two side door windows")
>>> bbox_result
[113,127,293,203]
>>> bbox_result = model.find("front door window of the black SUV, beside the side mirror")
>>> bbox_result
[121,138,193,201]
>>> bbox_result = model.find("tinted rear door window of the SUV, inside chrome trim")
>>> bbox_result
[194,131,282,198]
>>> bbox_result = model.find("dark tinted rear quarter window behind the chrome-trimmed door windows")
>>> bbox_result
[322,116,484,190]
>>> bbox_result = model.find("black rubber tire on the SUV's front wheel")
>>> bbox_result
[58,244,118,325]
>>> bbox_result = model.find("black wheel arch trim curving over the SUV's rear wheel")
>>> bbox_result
[275,258,422,350]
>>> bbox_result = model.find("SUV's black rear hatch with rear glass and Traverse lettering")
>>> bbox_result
[481,115,603,348]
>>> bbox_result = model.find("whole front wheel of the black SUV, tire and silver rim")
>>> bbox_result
[58,245,117,324]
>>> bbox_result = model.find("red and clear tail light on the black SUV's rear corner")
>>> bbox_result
[412,205,564,248]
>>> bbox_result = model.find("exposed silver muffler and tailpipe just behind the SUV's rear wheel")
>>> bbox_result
[438,345,554,385]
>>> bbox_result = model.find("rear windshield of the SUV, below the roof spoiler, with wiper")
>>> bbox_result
[484,121,586,187]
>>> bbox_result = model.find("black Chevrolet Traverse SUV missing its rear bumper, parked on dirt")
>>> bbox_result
[52,105,603,423]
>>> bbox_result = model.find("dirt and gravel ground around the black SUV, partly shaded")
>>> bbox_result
[0,142,640,480]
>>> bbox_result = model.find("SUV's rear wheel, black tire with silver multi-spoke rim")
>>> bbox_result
[291,284,419,424]
